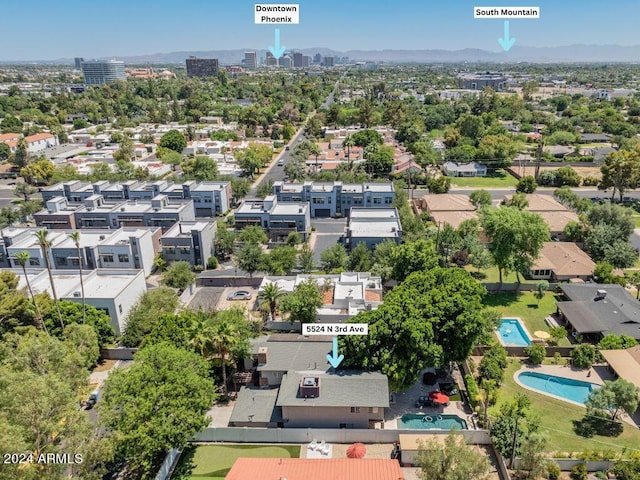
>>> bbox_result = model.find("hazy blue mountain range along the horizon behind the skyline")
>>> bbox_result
[1,45,640,65]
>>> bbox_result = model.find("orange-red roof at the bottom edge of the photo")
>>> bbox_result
[225,458,404,480]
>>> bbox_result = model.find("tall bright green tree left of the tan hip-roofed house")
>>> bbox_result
[480,207,549,285]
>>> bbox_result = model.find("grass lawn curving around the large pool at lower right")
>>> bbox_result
[489,359,640,453]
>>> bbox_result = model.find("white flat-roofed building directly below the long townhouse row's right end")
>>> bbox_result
[345,207,402,250]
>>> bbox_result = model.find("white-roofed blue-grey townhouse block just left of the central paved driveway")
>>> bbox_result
[234,195,311,242]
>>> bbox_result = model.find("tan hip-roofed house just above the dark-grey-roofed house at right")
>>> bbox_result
[531,242,596,282]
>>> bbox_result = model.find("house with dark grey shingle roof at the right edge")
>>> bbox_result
[556,283,640,342]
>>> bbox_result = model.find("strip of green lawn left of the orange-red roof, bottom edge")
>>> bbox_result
[172,445,300,480]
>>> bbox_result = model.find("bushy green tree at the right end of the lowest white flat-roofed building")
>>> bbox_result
[121,287,179,347]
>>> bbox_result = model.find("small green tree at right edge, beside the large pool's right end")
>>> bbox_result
[585,378,640,421]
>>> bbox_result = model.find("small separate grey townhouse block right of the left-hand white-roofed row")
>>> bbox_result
[160,221,216,268]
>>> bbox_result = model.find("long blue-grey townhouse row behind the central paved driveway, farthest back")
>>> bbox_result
[273,182,395,218]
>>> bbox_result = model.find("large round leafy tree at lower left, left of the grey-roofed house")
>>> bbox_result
[98,344,215,478]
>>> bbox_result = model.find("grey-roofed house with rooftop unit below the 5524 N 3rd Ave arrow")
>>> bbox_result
[276,370,389,429]
